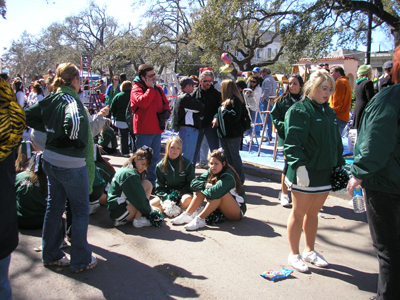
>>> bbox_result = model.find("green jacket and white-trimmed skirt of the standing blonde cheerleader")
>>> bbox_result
[284,97,345,194]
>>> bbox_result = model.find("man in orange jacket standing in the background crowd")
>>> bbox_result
[329,66,351,135]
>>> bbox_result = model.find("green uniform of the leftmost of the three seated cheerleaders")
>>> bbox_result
[107,167,152,222]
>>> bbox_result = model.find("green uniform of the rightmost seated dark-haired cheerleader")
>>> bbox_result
[190,169,247,216]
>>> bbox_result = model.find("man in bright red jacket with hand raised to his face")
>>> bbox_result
[131,64,171,186]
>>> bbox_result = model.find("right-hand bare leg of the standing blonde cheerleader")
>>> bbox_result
[303,192,329,252]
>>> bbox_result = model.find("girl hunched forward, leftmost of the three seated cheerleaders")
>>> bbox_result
[107,146,153,228]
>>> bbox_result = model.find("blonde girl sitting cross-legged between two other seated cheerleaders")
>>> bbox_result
[150,137,194,217]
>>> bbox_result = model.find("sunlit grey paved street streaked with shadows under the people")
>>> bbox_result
[10,157,378,300]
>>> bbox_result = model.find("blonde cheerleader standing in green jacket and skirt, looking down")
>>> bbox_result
[284,70,345,272]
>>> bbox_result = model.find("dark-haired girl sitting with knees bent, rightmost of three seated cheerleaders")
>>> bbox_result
[171,149,246,230]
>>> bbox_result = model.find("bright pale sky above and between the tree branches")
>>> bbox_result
[0,0,392,55]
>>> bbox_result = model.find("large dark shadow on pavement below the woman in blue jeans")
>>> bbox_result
[10,245,207,300]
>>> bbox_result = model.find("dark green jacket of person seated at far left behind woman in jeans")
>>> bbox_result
[15,171,47,229]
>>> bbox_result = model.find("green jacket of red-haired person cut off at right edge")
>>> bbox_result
[351,84,400,195]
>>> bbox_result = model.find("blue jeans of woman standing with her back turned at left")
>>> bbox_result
[42,161,92,270]
